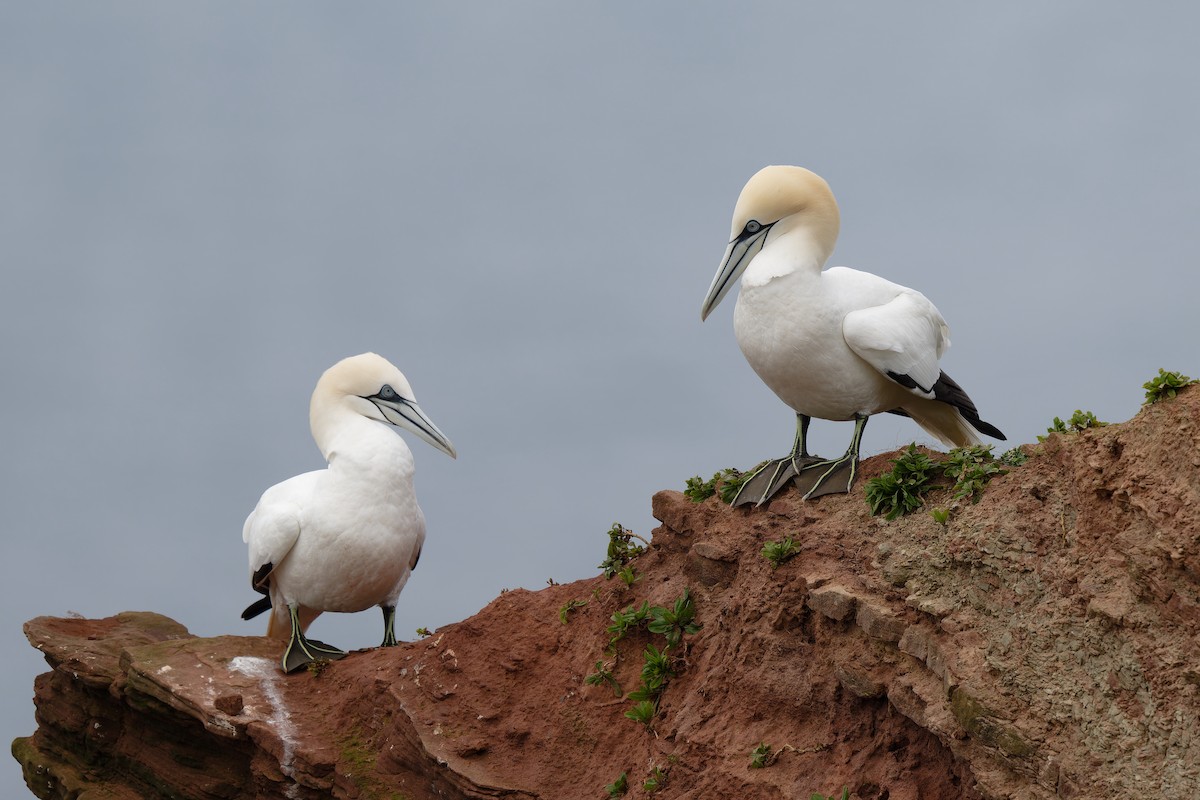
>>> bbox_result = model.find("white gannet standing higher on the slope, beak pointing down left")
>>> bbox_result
[700,167,1004,505]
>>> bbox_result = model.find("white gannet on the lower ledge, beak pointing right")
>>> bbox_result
[241,353,456,672]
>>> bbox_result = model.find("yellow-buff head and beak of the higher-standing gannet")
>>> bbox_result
[700,167,840,320]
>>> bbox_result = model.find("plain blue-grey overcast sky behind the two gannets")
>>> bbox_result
[0,6,1200,794]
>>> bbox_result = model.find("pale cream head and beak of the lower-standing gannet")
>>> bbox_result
[308,353,457,458]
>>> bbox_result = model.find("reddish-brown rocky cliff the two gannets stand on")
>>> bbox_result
[13,389,1200,800]
